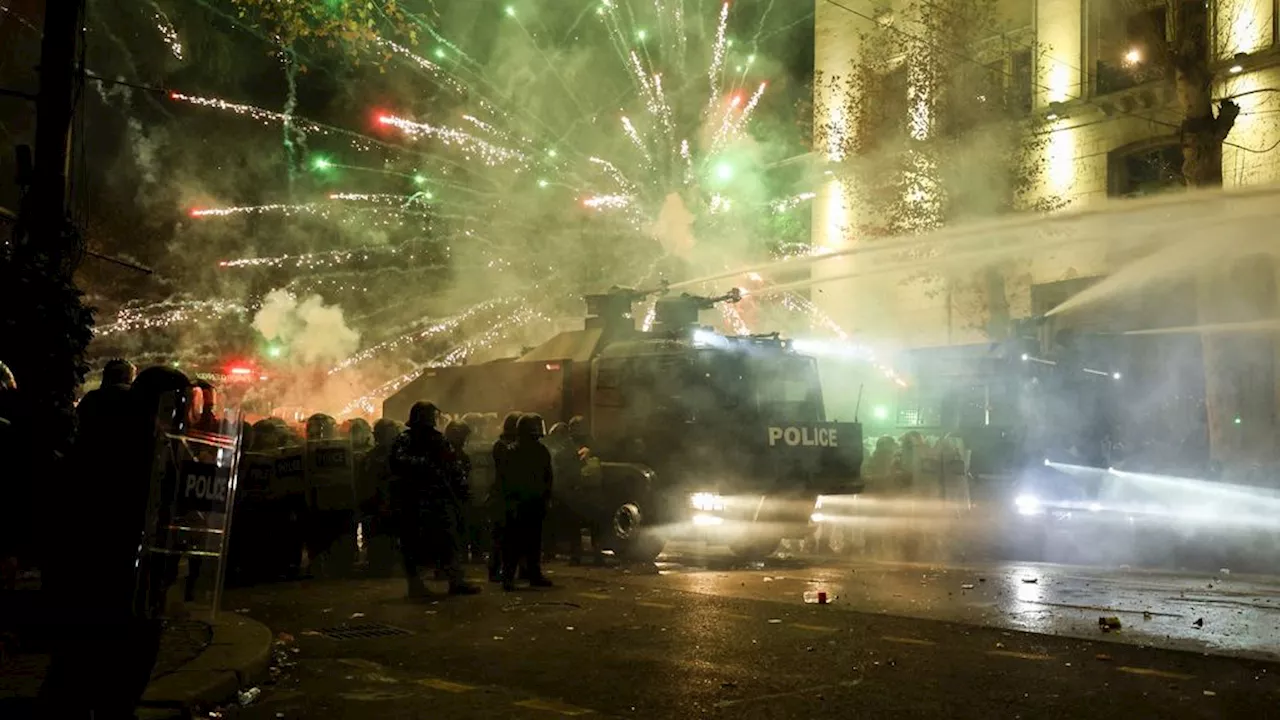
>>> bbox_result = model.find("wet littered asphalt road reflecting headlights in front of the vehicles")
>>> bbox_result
[215,552,1280,719]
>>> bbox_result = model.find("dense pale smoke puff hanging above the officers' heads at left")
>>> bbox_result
[253,290,360,365]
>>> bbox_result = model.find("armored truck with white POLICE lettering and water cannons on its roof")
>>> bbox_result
[383,290,863,560]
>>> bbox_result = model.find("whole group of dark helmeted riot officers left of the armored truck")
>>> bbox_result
[0,360,611,716]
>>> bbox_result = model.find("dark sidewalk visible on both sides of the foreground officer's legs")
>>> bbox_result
[0,597,273,720]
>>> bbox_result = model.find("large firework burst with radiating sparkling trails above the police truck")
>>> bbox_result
[127,0,819,412]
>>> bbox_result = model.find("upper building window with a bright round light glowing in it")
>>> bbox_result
[1092,0,1170,95]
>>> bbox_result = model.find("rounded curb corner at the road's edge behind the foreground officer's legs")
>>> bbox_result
[142,612,274,708]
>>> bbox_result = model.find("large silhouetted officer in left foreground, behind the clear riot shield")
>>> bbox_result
[41,366,195,717]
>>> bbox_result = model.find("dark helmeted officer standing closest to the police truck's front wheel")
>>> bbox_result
[497,414,553,591]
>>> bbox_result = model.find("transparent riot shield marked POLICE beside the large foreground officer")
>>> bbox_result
[134,391,241,620]
